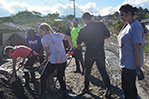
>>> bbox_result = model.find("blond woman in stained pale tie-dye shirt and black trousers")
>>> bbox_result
[38,23,73,99]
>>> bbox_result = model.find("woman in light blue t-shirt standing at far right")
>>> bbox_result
[118,4,145,99]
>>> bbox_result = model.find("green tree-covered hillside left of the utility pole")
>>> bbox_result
[0,11,74,32]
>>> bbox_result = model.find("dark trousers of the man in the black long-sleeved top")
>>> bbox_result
[85,56,111,89]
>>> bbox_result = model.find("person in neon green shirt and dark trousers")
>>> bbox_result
[71,18,84,74]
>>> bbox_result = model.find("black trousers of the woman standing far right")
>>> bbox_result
[122,68,137,99]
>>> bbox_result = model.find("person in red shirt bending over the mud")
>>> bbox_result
[4,45,43,87]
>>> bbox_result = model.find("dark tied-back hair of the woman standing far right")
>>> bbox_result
[119,4,138,16]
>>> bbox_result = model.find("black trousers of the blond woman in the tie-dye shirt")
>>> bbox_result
[40,62,67,94]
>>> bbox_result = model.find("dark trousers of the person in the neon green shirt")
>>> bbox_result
[73,48,84,72]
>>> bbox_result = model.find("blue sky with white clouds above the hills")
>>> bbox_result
[0,0,149,17]
